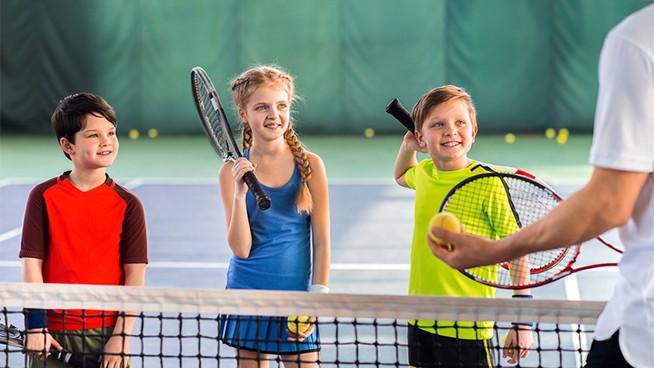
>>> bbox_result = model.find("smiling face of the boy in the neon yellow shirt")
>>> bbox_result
[416,99,477,170]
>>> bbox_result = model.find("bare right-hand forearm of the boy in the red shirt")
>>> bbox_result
[104,263,145,367]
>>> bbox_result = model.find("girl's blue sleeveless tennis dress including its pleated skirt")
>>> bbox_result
[220,151,320,354]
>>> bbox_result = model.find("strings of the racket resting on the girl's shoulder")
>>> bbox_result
[193,76,234,161]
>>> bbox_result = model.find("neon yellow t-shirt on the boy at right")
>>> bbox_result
[404,158,518,340]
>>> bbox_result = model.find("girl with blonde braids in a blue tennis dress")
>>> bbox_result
[219,66,330,368]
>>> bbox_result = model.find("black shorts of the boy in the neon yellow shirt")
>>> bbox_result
[407,324,495,368]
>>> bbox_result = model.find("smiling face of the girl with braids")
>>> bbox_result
[239,84,291,140]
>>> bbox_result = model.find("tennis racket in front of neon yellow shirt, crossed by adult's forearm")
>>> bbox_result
[439,172,622,289]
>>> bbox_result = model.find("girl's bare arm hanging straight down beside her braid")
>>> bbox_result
[307,152,331,286]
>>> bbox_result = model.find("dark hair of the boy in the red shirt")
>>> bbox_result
[50,92,118,160]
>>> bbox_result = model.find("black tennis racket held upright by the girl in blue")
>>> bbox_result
[191,66,271,211]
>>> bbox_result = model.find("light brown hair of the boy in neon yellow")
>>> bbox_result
[411,85,477,130]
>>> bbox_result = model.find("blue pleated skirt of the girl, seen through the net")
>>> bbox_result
[220,315,320,354]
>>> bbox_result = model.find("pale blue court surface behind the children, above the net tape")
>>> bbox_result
[0,136,620,364]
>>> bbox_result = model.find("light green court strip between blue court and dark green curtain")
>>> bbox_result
[0,134,592,183]
